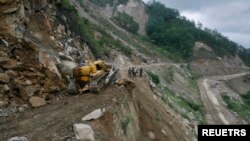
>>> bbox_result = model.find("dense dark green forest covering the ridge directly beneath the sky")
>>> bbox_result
[146,1,250,65]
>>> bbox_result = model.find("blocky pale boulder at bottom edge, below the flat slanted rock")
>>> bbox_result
[74,124,95,141]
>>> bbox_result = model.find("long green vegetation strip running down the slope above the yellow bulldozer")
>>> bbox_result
[58,0,132,58]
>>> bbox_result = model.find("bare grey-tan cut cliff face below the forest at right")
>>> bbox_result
[192,42,248,75]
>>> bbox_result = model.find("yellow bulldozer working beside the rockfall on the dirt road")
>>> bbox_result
[73,60,119,93]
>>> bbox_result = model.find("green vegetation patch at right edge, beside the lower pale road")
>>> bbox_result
[222,91,250,123]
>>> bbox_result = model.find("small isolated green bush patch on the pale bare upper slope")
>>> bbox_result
[114,12,139,33]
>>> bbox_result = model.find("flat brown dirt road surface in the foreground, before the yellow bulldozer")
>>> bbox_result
[0,87,125,141]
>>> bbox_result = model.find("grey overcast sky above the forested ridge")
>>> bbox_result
[143,0,250,48]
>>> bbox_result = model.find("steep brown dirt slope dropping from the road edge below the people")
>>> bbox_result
[133,78,194,141]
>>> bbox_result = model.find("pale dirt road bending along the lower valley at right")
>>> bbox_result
[198,72,250,124]
